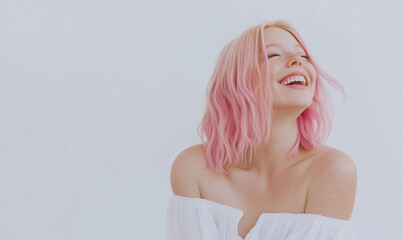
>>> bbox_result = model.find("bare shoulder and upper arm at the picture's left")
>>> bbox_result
[171,144,206,197]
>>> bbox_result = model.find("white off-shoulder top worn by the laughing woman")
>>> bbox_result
[166,195,357,240]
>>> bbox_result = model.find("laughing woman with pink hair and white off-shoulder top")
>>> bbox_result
[166,20,357,240]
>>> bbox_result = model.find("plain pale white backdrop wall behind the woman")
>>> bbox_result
[0,0,403,240]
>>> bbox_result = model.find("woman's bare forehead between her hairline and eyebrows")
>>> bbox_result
[263,27,301,48]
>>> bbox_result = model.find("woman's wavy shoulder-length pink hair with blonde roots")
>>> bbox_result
[197,20,345,173]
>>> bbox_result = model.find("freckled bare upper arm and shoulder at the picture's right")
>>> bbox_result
[305,151,357,220]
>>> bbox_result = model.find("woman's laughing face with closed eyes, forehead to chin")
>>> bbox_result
[264,27,316,112]
